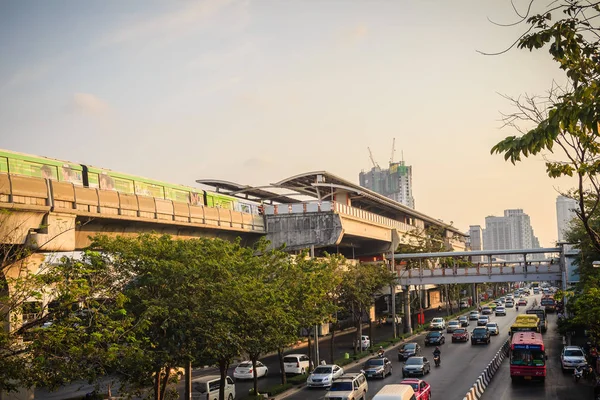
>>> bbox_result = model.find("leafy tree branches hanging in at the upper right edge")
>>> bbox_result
[491,0,600,250]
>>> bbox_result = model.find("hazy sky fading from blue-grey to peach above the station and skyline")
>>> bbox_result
[0,0,575,246]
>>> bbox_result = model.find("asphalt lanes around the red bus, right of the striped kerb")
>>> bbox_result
[481,314,594,400]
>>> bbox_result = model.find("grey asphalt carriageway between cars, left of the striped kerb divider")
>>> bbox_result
[286,296,528,400]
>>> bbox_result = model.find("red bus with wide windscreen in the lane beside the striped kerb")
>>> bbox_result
[510,332,548,381]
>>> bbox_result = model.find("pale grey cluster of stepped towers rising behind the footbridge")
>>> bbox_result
[482,209,545,261]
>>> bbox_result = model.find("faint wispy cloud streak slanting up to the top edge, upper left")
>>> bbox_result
[99,0,231,45]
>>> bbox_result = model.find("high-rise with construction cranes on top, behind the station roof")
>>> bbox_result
[358,161,415,208]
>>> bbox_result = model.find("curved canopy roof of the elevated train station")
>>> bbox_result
[196,171,465,236]
